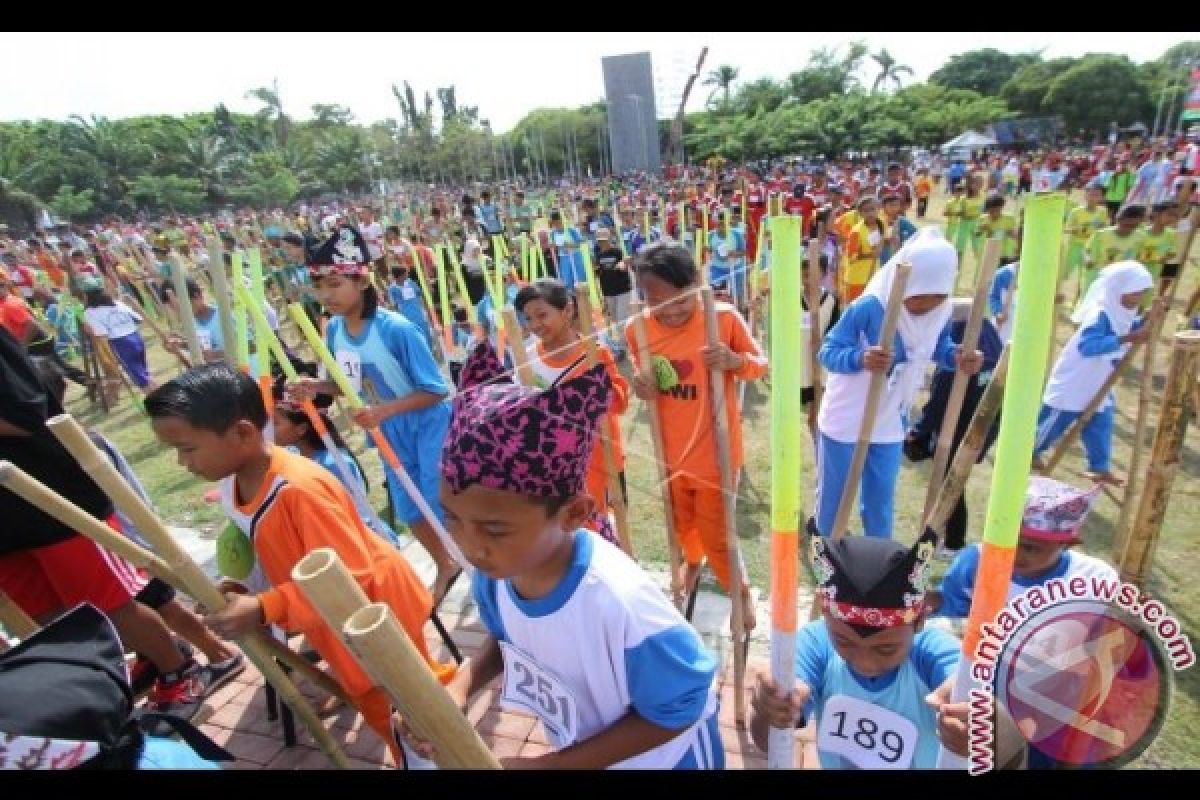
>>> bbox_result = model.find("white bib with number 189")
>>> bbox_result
[817,694,917,770]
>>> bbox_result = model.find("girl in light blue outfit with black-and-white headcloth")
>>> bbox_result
[295,227,458,600]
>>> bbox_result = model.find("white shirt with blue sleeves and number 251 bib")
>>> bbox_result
[472,529,722,769]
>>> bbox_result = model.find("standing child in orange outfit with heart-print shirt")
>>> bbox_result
[625,245,767,630]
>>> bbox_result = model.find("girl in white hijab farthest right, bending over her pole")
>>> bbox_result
[1033,261,1154,483]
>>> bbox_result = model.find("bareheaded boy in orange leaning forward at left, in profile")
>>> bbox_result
[145,363,455,764]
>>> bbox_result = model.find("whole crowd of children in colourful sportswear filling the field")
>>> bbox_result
[0,128,1190,769]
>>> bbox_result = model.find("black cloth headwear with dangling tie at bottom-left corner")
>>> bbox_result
[0,603,233,770]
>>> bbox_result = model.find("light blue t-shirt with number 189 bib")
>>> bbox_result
[796,619,961,769]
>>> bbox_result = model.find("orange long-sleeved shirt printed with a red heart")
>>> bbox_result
[625,299,767,486]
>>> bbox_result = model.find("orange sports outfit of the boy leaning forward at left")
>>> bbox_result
[246,447,455,697]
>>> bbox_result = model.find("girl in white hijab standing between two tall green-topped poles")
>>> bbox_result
[816,228,983,537]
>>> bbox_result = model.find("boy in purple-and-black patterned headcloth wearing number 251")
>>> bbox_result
[403,345,724,769]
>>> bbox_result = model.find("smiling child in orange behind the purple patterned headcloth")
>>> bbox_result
[514,278,629,543]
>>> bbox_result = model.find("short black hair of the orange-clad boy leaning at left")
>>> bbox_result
[145,361,266,433]
